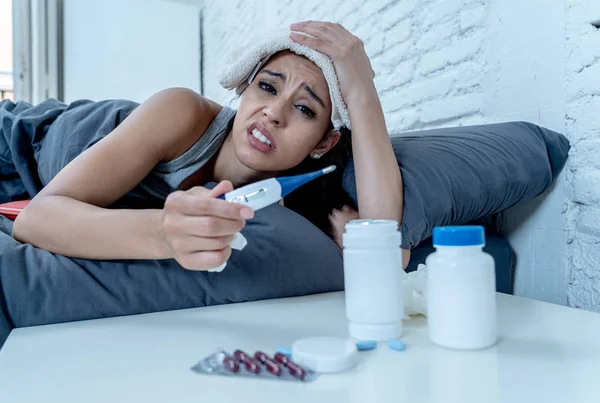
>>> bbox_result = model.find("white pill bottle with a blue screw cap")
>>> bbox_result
[425,226,497,350]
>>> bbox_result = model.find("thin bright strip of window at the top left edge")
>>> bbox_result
[0,0,14,100]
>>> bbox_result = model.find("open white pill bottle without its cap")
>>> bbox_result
[343,220,404,341]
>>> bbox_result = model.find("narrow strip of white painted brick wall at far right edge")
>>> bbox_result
[566,0,600,310]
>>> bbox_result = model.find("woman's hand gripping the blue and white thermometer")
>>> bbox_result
[159,181,254,270]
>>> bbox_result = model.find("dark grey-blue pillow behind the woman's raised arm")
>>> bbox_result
[343,122,569,249]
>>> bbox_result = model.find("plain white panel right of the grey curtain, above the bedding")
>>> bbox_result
[64,0,200,102]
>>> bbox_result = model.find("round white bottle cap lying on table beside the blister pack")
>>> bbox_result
[292,337,358,373]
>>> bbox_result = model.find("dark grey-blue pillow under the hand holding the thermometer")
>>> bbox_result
[0,204,344,347]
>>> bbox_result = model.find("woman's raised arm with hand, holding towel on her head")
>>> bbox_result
[291,22,410,268]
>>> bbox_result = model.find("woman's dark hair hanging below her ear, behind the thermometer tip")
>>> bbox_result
[285,125,356,238]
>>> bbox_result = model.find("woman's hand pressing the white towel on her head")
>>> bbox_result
[290,21,375,102]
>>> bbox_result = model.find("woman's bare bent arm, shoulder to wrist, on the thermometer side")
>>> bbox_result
[13,89,227,259]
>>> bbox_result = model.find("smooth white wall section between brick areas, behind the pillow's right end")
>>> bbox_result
[483,0,567,304]
